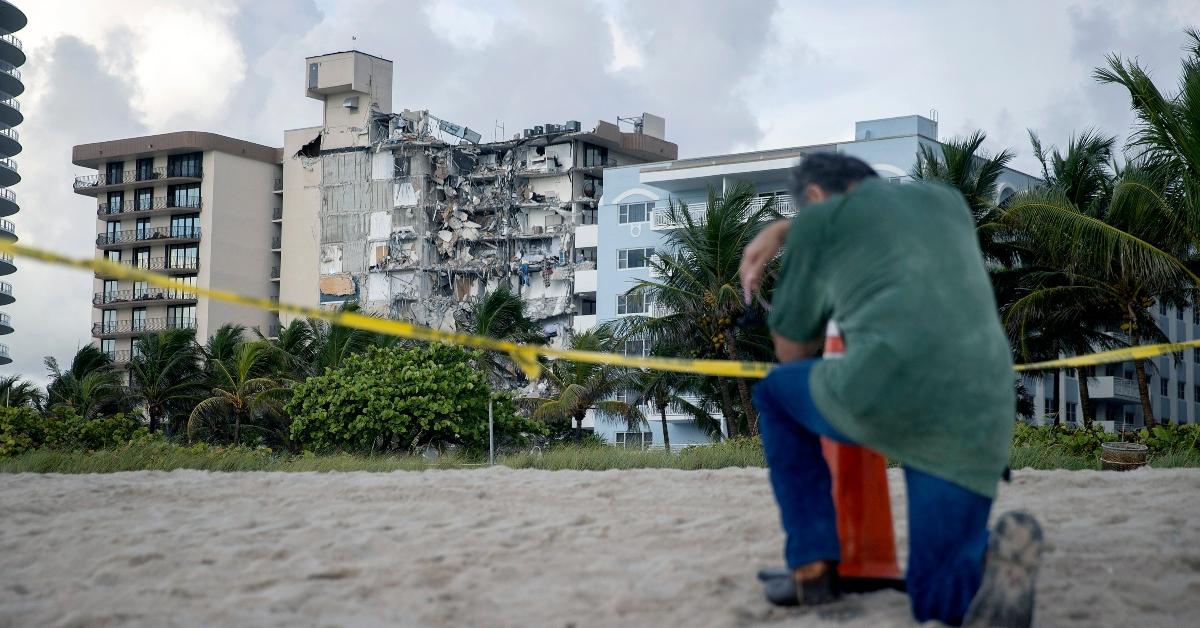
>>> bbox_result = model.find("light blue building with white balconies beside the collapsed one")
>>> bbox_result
[575,115,1038,447]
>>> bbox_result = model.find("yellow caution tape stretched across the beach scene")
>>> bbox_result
[0,240,1200,379]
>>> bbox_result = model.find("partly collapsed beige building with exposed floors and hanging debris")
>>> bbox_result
[278,52,678,339]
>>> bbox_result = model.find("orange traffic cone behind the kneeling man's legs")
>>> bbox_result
[821,321,900,580]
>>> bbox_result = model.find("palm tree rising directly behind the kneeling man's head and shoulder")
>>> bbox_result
[910,131,1015,267]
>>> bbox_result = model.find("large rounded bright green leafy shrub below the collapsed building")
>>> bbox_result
[284,345,542,451]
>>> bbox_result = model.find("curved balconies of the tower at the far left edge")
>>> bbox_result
[0,0,29,365]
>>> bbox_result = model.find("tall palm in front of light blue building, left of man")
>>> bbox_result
[622,181,779,436]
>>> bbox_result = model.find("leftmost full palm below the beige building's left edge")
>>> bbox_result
[44,345,130,419]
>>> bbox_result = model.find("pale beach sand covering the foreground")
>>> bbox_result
[0,468,1200,628]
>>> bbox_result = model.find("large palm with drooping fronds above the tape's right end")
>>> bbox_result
[1006,166,1200,426]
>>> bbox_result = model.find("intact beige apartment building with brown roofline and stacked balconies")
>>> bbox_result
[72,131,282,365]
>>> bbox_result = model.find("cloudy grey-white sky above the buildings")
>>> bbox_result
[0,0,1200,383]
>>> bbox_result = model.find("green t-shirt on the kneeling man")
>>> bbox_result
[770,179,1016,497]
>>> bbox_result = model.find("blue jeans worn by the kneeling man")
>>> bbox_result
[754,360,1000,626]
